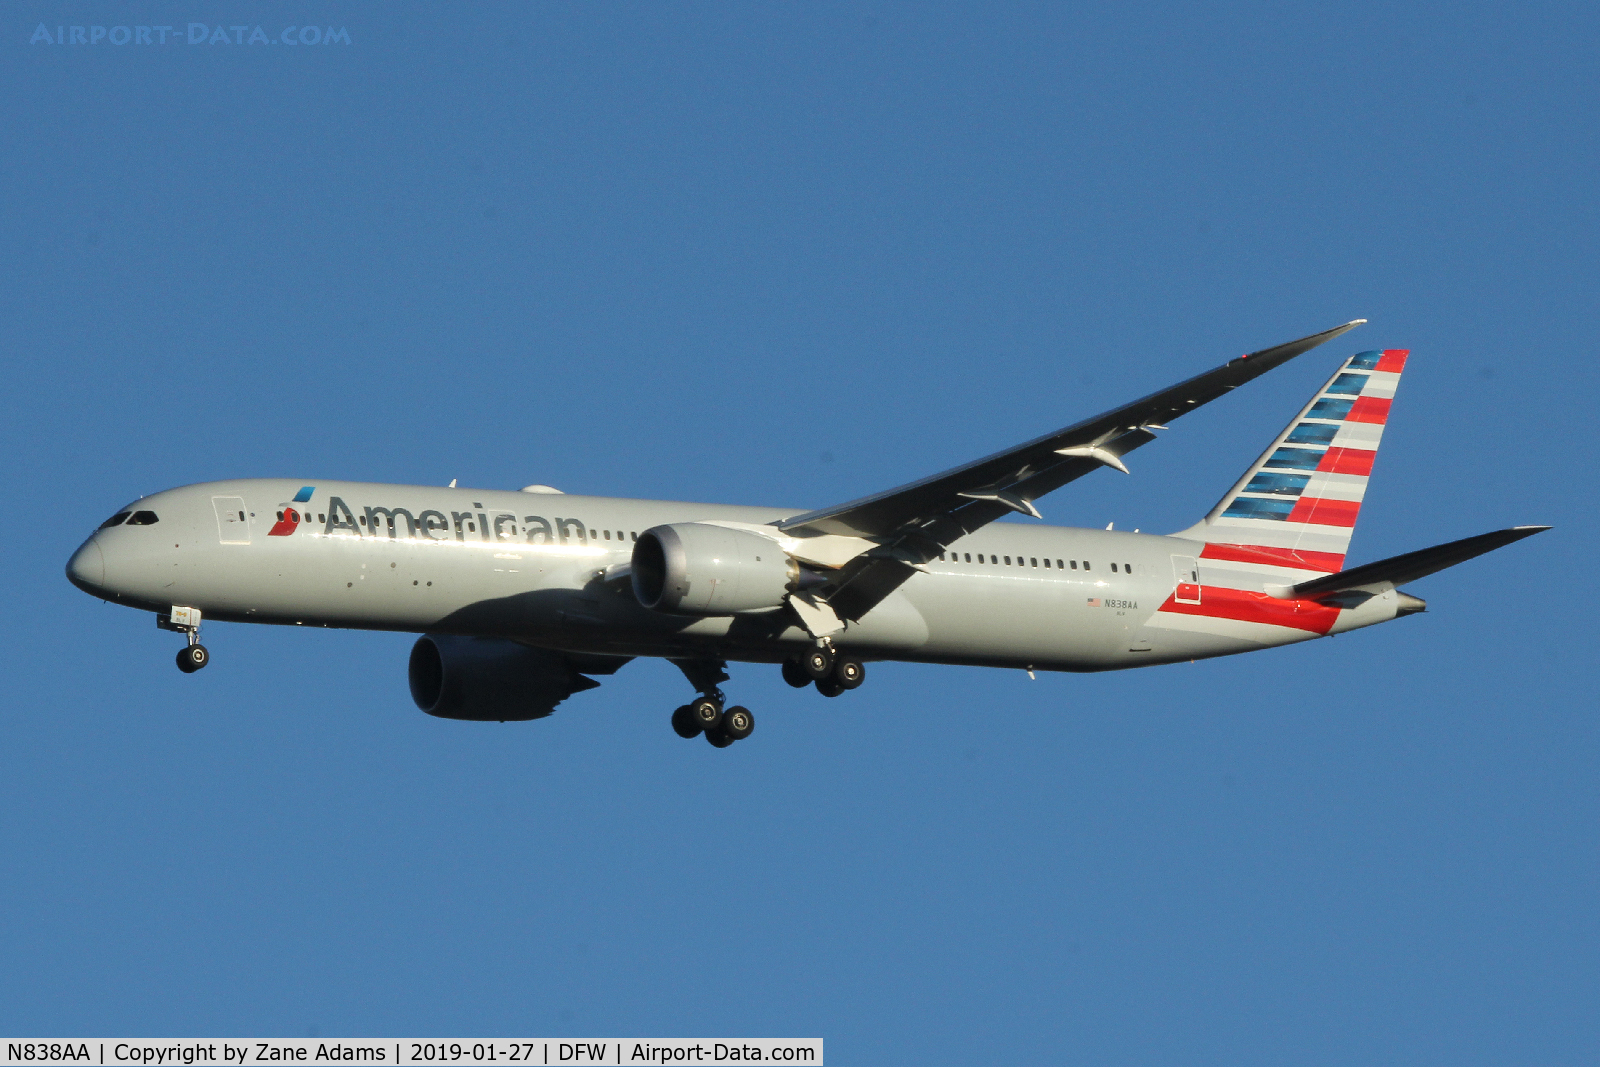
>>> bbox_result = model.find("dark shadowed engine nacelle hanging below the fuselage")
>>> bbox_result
[406,633,600,721]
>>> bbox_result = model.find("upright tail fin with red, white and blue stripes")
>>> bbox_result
[1176,349,1406,581]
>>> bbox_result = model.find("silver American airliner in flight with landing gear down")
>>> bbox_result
[67,318,1549,749]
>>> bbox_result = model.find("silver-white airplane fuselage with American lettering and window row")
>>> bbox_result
[67,478,1395,670]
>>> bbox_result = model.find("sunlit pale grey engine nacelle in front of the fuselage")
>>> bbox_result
[634,523,800,616]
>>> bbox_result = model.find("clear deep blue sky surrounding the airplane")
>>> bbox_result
[0,3,1600,1065]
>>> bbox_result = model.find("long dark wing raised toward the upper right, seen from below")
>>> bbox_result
[778,318,1366,619]
